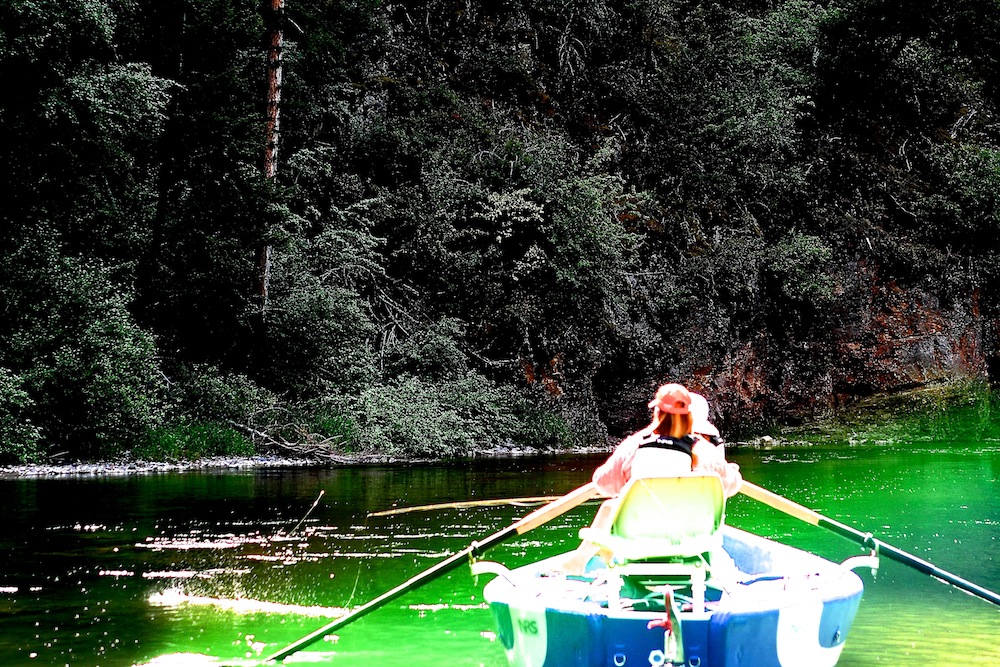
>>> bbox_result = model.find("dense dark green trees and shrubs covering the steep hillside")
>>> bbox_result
[0,0,1000,460]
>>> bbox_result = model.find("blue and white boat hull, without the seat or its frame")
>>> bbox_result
[484,527,873,667]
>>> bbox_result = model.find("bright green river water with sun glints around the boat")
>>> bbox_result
[0,410,1000,667]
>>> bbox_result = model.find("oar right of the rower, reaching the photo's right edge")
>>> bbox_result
[740,480,1000,605]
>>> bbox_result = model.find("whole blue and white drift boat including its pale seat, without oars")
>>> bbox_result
[473,474,878,667]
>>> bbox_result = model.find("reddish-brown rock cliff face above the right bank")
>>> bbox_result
[691,263,984,432]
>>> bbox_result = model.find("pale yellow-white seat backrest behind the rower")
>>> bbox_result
[611,473,726,544]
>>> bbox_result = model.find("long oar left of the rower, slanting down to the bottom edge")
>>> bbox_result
[265,483,597,662]
